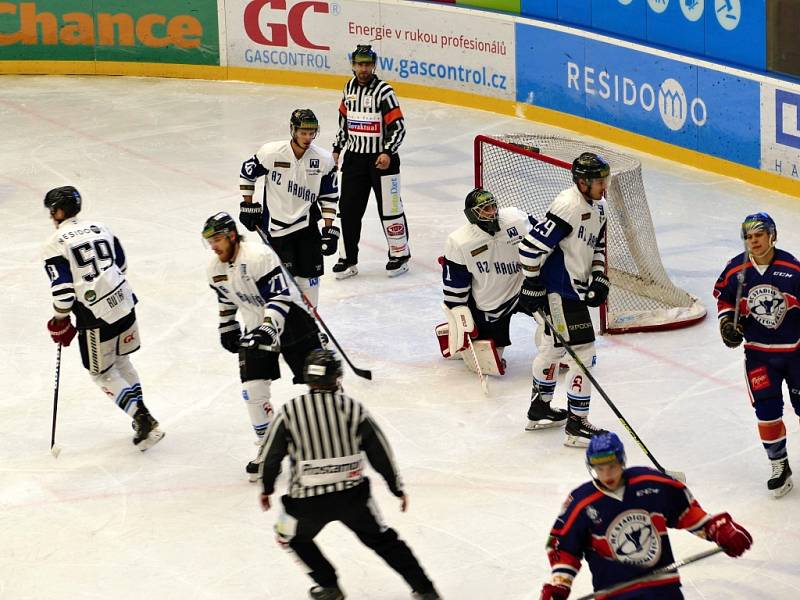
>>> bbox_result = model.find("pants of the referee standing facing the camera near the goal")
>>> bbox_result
[339,151,410,265]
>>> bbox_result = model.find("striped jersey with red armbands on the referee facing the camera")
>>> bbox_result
[333,75,406,154]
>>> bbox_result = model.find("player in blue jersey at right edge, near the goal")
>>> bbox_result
[714,212,800,497]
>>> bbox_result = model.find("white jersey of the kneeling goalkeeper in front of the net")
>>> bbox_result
[442,207,535,320]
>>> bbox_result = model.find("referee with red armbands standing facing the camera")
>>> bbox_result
[333,45,411,279]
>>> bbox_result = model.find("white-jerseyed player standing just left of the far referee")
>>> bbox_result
[239,108,339,306]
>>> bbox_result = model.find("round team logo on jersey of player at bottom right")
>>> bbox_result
[606,510,661,567]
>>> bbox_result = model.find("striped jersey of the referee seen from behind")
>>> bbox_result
[259,390,403,498]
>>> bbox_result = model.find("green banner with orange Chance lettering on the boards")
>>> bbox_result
[0,0,219,65]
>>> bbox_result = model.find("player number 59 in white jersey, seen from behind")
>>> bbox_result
[43,185,164,452]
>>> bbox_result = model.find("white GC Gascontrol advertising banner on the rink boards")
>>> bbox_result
[226,0,516,99]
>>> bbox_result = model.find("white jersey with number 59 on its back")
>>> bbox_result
[42,218,136,328]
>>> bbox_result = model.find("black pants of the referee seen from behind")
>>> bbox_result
[282,478,433,593]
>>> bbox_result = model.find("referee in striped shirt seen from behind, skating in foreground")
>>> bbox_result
[260,350,439,600]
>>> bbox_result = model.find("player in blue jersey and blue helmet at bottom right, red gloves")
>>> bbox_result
[540,432,753,600]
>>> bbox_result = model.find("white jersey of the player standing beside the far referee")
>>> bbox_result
[239,140,339,237]
